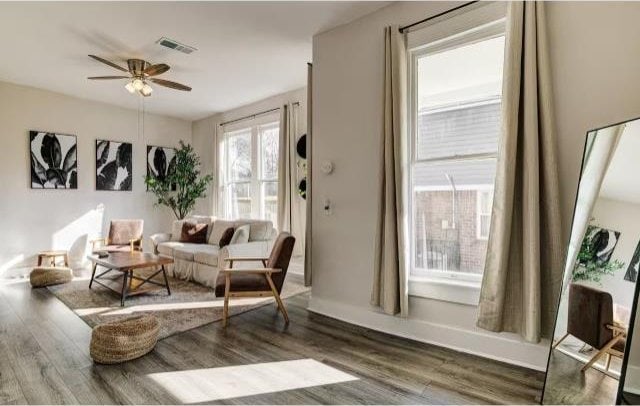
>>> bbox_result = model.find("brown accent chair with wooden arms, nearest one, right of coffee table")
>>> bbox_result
[215,233,296,327]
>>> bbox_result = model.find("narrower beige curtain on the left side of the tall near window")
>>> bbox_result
[371,26,408,316]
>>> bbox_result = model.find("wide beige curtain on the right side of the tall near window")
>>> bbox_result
[477,1,565,342]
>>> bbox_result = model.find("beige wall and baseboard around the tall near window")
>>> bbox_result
[311,2,640,369]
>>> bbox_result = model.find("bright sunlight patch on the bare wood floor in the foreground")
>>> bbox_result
[148,359,358,403]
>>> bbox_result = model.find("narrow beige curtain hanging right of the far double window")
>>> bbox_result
[278,104,291,232]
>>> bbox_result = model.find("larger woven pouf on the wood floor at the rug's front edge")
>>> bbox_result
[89,314,160,364]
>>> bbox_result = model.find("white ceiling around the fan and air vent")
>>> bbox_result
[0,2,388,120]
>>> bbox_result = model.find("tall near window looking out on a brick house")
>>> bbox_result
[409,8,504,283]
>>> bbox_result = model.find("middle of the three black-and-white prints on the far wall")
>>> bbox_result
[96,140,133,191]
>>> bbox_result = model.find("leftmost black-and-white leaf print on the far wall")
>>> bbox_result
[29,131,78,189]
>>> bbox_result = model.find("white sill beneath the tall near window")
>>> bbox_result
[409,276,480,306]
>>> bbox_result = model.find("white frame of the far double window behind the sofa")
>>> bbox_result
[217,113,280,221]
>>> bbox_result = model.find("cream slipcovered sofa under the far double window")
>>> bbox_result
[151,216,277,288]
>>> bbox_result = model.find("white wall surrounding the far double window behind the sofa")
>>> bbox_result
[193,87,307,256]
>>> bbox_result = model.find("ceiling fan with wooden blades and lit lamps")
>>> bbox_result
[87,55,191,97]
